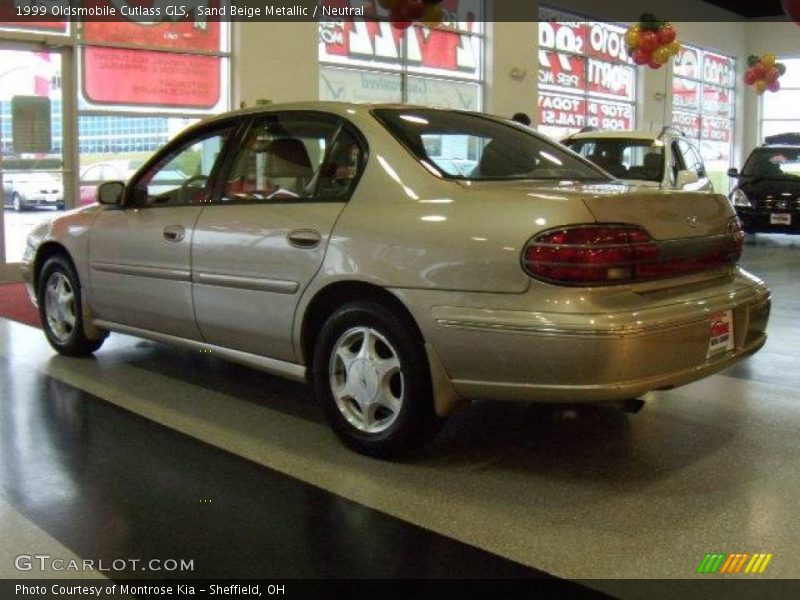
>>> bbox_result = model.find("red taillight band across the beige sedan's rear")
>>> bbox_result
[522,221,743,285]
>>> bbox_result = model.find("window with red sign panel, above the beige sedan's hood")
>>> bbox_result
[78,21,230,200]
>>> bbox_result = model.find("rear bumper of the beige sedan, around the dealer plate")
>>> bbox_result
[396,270,770,402]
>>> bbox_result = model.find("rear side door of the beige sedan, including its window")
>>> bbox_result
[192,111,366,361]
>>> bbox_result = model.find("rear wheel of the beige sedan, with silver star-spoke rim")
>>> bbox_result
[313,301,444,458]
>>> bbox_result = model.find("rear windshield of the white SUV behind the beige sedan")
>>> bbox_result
[566,138,664,181]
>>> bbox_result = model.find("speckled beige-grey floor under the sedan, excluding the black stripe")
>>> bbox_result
[0,236,800,579]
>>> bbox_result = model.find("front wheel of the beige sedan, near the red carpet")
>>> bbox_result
[38,255,106,356]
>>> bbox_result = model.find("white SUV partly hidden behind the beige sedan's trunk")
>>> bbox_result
[563,127,714,192]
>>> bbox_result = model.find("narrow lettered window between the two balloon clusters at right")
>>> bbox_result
[672,45,736,193]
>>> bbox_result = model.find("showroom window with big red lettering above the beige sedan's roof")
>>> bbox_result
[319,0,484,110]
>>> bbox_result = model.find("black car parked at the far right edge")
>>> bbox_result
[728,133,800,233]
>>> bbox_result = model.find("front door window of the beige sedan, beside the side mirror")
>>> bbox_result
[134,127,234,206]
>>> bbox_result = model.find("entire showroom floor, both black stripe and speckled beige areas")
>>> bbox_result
[0,236,800,587]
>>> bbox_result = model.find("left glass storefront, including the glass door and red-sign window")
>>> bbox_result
[0,20,231,269]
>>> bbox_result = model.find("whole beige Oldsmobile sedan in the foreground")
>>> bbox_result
[24,103,770,457]
